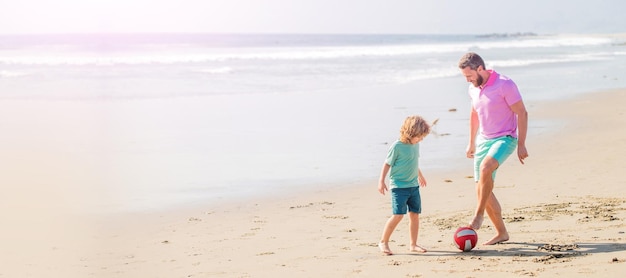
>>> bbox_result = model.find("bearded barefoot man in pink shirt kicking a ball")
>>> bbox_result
[459,52,528,245]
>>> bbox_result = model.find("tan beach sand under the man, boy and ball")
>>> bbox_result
[0,90,626,277]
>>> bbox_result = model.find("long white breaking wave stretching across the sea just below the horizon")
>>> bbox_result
[0,37,612,67]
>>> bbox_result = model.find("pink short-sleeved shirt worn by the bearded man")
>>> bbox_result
[469,70,522,139]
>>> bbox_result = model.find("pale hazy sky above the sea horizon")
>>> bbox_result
[0,0,626,34]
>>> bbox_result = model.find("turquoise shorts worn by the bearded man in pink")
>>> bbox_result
[474,135,517,181]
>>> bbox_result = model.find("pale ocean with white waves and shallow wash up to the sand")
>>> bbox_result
[0,34,626,211]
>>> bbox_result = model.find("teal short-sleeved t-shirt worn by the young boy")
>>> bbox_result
[385,140,420,188]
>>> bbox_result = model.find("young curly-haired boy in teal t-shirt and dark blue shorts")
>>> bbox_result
[378,116,430,255]
